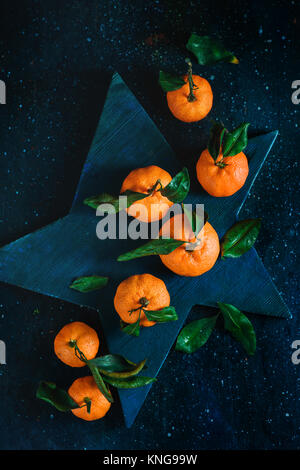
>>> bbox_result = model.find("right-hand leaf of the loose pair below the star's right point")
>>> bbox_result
[218,302,256,356]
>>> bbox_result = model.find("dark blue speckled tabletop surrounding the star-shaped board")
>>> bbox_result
[0,0,300,449]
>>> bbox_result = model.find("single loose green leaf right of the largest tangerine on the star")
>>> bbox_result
[221,219,261,258]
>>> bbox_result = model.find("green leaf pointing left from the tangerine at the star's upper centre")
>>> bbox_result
[83,190,149,214]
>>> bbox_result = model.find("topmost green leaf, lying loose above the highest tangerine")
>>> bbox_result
[186,33,239,65]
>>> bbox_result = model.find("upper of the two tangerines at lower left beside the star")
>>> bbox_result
[54,322,99,367]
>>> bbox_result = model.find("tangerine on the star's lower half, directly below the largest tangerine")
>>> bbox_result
[114,274,170,327]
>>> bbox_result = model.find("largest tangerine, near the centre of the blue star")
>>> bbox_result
[159,214,220,277]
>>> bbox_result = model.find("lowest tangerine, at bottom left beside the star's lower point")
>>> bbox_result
[68,376,111,421]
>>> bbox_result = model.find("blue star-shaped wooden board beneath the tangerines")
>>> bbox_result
[0,74,290,426]
